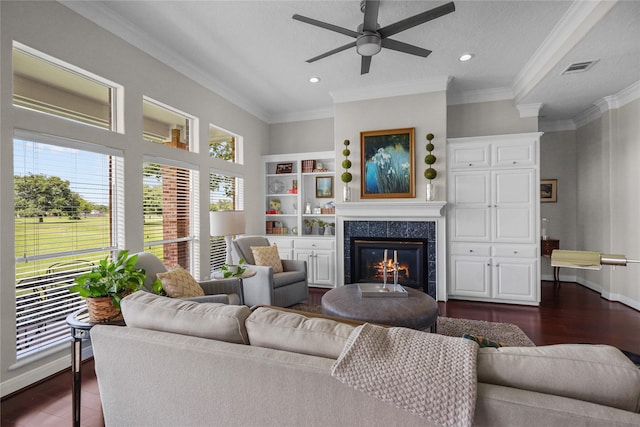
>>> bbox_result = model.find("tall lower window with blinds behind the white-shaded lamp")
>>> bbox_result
[209,172,244,272]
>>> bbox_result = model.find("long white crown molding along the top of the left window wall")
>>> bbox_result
[58,0,271,123]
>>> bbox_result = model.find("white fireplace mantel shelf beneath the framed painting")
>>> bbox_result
[335,201,447,219]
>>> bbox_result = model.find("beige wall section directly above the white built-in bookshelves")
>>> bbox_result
[269,119,334,154]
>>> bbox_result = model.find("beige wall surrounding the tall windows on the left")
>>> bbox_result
[0,1,269,396]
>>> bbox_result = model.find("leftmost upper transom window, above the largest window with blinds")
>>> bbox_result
[13,42,123,133]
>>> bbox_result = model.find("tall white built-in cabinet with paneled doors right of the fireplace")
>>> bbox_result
[447,133,541,305]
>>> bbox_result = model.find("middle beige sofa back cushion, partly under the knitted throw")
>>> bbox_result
[246,307,354,359]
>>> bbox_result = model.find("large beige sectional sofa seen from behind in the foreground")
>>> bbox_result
[91,292,640,427]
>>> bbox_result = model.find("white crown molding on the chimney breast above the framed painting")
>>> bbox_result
[329,76,451,104]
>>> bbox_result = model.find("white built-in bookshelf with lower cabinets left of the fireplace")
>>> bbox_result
[262,151,339,287]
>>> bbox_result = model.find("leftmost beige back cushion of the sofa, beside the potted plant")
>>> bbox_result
[121,291,251,344]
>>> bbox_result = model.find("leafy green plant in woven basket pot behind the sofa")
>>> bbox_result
[69,250,146,323]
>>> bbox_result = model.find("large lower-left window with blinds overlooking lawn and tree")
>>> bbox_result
[14,132,124,358]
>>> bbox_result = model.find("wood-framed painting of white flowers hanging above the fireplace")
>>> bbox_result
[360,128,416,199]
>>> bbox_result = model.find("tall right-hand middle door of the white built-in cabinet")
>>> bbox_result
[492,169,537,243]
